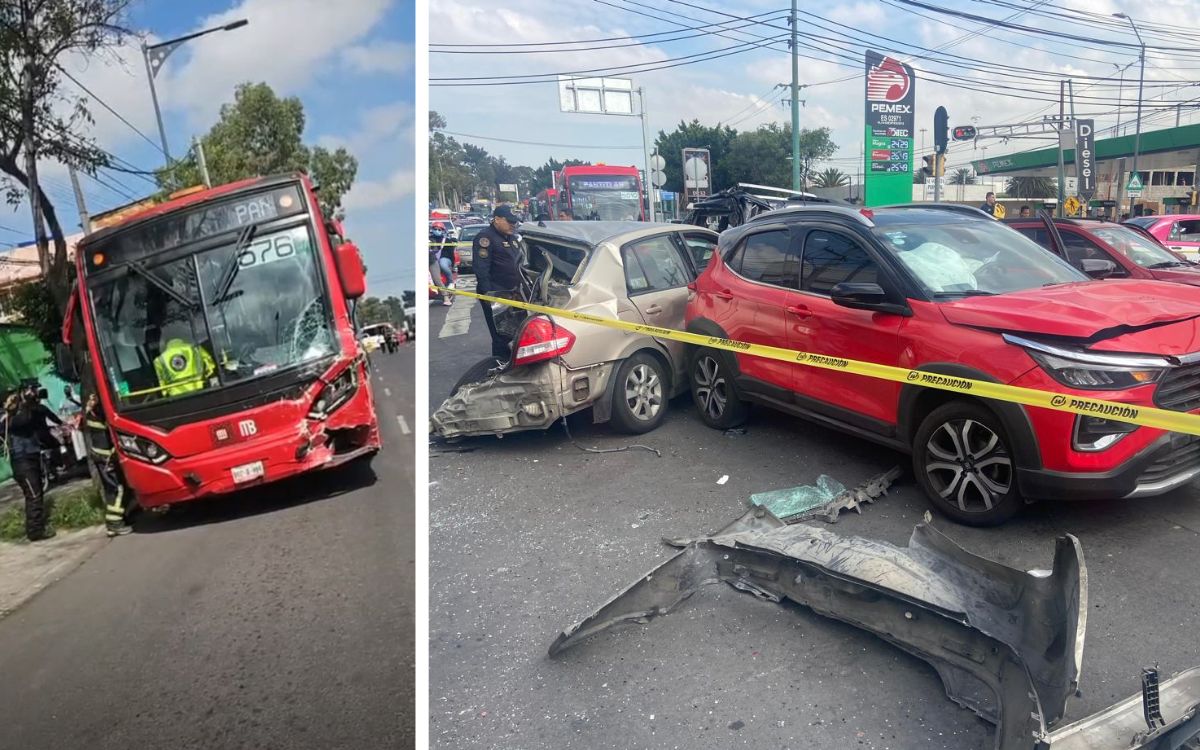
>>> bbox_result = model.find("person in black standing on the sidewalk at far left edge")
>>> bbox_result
[0,386,62,541]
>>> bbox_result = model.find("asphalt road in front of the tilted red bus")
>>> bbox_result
[0,344,415,750]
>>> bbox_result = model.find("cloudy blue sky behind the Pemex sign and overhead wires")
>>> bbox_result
[430,0,1200,184]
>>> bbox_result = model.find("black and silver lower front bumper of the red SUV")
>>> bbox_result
[1018,433,1200,500]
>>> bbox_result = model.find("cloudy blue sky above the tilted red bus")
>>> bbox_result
[0,0,415,295]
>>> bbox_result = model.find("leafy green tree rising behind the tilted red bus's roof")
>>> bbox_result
[158,83,359,214]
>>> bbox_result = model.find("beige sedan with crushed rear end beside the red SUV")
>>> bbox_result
[431,222,716,438]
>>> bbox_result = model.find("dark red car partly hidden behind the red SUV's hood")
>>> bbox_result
[1004,218,1200,286]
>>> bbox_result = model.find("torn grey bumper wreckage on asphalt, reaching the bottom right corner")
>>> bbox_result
[550,508,1200,750]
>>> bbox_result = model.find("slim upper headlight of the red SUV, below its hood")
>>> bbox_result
[1004,334,1171,391]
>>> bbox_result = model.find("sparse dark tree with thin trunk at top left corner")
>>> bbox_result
[0,0,128,310]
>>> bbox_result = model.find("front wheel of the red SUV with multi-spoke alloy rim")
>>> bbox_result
[912,401,1022,526]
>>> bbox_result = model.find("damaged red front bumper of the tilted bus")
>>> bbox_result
[121,386,380,508]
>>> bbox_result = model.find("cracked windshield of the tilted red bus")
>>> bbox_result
[92,226,336,404]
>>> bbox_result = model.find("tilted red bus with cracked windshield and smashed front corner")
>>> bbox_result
[64,174,380,508]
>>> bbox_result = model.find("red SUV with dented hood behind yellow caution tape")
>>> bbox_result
[686,201,1200,526]
